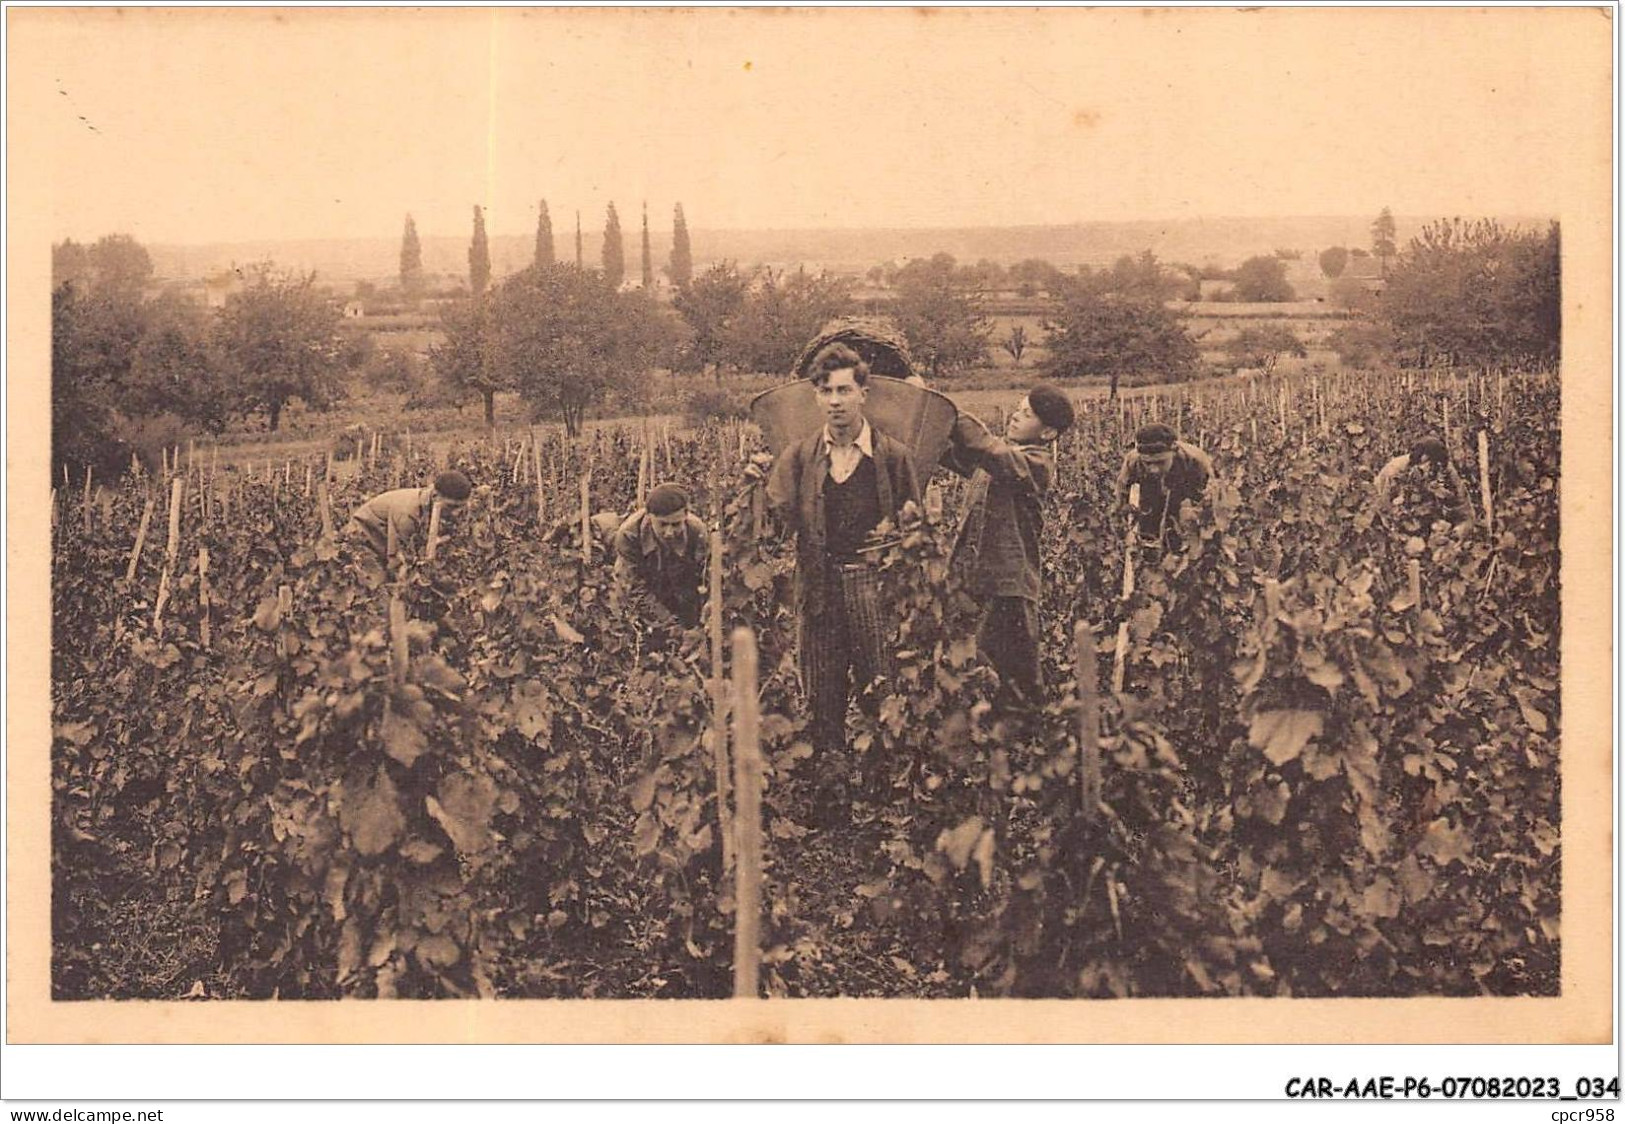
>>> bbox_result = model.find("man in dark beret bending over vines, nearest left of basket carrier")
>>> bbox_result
[614,484,710,629]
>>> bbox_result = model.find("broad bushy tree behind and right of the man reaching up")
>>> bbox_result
[1042,275,1199,396]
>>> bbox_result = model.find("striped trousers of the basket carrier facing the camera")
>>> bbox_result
[796,564,892,767]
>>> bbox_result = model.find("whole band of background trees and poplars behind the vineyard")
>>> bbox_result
[52,201,1562,468]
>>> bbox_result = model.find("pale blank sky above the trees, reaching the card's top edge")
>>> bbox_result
[7,8,1610,242]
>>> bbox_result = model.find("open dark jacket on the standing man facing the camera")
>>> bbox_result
[767,426,920,617]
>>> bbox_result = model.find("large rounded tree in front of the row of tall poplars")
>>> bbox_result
[491,266,660,435]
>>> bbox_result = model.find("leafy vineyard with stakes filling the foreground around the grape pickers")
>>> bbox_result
[52,372,1562,999]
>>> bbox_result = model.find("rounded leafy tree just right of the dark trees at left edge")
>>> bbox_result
[216,263,345,432]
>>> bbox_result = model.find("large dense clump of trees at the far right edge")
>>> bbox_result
[1375,219,1562,367]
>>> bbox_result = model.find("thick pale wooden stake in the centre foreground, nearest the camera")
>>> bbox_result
[733,629,762,999]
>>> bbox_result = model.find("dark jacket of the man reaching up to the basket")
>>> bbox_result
[943,414,1055,601]
